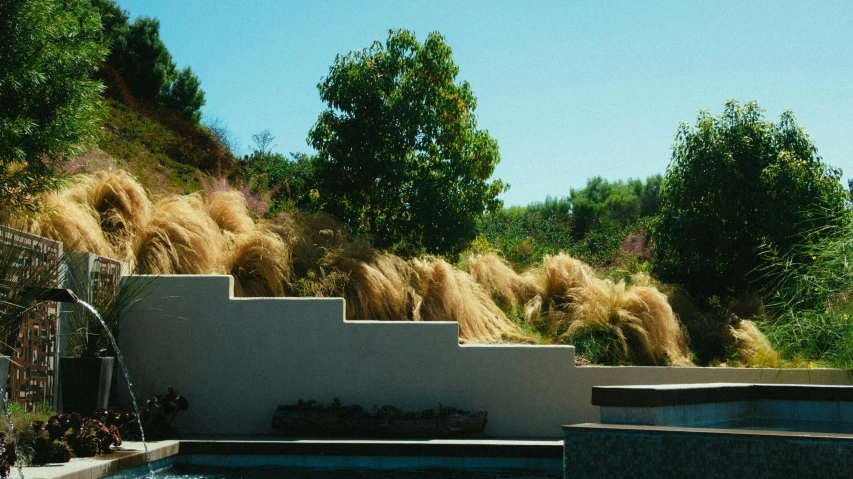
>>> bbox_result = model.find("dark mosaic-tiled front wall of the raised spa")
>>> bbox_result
[563,427,853,479]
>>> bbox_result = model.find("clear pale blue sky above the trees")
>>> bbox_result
[117,0,853,205]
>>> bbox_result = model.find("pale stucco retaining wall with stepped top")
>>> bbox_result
[119,276,853,438]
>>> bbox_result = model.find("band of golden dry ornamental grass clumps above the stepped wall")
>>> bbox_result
[20,171,704,364]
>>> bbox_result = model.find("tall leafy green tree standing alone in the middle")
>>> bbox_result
[309,30,505,253]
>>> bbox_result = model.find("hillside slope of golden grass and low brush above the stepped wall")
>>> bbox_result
[5,78,763,365]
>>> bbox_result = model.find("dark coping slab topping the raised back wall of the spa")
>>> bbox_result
[592,383,853,407]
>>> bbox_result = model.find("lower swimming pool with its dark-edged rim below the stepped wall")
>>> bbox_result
[96,436,563,479]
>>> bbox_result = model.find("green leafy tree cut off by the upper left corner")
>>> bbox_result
[0,0,106,209]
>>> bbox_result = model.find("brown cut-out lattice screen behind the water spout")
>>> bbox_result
[0,227,62,409]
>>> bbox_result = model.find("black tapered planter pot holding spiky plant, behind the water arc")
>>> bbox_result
[59,358,115,416]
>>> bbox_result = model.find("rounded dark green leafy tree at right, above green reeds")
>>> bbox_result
[653,100,846,295]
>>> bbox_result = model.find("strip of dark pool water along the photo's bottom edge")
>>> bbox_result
[149,464,563,479]
